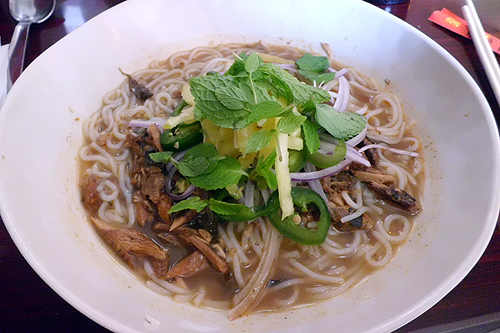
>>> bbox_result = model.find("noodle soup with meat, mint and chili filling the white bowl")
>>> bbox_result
[79,42,424,320]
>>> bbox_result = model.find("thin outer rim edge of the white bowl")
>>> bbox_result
[0,0,500,331]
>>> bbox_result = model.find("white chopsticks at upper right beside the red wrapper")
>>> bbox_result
[462,0,500,103]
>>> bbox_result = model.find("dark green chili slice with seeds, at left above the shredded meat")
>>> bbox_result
[161,122,203,151]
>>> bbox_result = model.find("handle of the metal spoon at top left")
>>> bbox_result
[7,22,31,90]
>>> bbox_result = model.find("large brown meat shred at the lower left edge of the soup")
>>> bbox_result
[90,217,170,269]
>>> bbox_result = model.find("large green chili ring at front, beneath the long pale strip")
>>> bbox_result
[267,187,331,245]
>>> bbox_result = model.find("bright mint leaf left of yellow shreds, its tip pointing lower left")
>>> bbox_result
[188,156,247,190]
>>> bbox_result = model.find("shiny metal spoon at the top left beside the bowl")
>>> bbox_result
[7,0,56,90]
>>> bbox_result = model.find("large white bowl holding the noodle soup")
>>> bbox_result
[0,0,500,332]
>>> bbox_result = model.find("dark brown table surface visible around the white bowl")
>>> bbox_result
[0,0,500,332]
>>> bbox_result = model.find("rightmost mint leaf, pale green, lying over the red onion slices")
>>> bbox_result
[316,104,366,140]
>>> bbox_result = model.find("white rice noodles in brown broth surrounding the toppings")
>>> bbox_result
[78,41,424,320]
